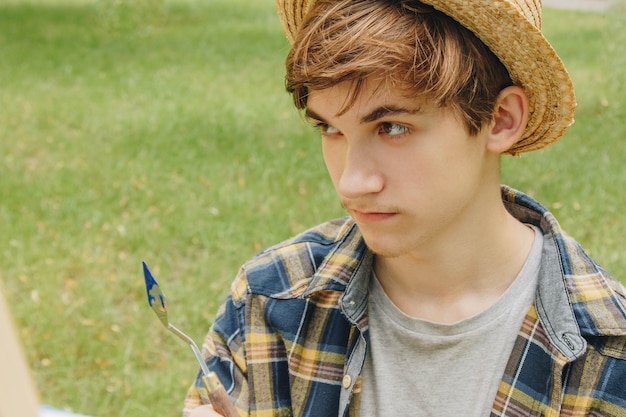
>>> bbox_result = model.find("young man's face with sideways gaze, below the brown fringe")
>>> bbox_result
[307,81,499,257]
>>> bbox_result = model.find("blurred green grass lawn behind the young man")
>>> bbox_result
[0,0,626,417]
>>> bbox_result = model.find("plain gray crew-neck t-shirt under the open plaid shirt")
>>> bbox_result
[360,229,543,417]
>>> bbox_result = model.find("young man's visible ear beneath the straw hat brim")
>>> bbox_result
[487,85,529,153]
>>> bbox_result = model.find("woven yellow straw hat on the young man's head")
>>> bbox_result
[276,0,576,154]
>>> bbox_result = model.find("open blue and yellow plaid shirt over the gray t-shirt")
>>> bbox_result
[183,187,626,417]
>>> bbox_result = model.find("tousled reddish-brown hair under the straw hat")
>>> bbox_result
[286,0,512,134]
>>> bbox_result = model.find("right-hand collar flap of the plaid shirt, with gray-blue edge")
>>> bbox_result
[502,186,626,357]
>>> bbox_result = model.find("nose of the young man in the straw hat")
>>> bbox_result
[336,142,384,199]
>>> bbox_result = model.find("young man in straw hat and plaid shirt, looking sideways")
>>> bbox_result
[185,0,626,417]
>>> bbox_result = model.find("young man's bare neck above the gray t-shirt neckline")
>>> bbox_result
[374,194,534,323]
